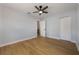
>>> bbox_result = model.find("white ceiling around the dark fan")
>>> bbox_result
[2,3,77,18]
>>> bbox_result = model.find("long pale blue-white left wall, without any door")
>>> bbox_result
[0,6,37,45]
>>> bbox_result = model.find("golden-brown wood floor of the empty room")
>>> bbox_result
[0,37,78,55]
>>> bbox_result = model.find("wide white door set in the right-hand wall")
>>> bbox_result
[60,17,71,41]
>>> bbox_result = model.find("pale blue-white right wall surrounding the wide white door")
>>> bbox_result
[46,9,77,42]
